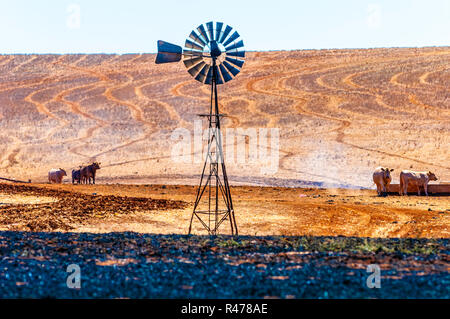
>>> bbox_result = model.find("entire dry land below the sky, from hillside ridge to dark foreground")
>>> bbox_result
[0,47,450,298]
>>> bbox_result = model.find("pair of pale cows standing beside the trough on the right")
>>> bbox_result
[373,167,438,196]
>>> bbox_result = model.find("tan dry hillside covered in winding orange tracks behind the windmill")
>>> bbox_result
[0,47,450,187]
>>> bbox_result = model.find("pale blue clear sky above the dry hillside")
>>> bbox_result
[0,0,450,54]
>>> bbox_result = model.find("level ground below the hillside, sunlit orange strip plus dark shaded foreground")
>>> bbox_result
[0,183,450,299]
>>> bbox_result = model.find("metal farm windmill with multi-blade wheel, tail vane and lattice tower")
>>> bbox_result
[156,22,245,235]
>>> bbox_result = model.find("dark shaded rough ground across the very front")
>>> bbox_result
[0,232,450,298]
